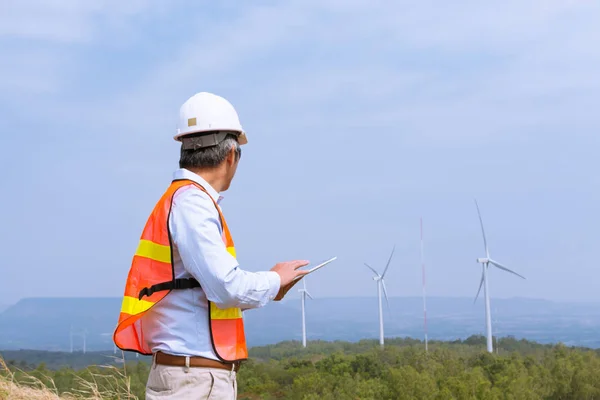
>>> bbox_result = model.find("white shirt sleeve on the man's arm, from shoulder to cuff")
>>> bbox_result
[169,188,280,309]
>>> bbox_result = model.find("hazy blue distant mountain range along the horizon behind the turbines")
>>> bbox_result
[0,297,600,351]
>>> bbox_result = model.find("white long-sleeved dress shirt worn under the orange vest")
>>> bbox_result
[142,169,280,360]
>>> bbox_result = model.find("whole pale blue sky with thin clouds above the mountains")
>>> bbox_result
[0,0,600,303]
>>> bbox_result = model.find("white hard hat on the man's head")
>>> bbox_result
[173,92,248,145]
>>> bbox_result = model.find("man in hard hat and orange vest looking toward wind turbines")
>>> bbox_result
[113,92,308,400]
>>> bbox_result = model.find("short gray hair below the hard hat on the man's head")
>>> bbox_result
[179,134,242,169]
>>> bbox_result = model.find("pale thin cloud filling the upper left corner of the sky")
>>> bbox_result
[0,0,176,106]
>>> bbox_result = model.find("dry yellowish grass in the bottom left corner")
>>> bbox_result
[0,357,137,400]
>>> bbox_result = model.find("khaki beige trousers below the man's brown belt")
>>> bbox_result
[146,363,237,400]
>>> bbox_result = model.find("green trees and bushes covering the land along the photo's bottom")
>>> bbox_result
[0,337,600,400]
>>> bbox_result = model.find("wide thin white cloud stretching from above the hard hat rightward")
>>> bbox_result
[101,0,600,140]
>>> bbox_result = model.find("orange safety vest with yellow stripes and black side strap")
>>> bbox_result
[113,179,248,361]
